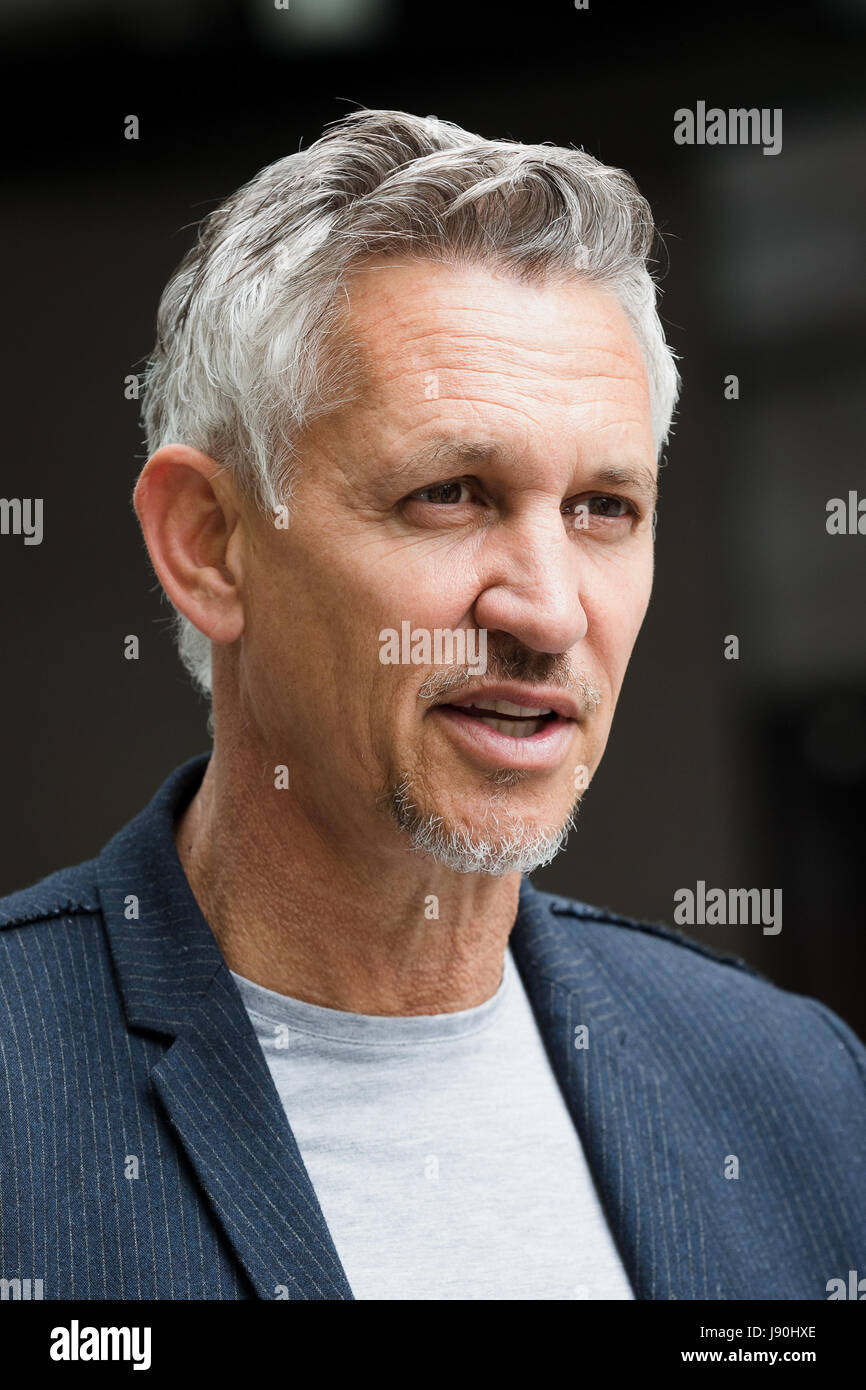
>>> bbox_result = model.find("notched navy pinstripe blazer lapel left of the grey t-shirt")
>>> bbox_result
[99,758,353,1300]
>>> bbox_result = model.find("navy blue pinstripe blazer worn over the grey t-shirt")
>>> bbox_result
[0,756,866,1300]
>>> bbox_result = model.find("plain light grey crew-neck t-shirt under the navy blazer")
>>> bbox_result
[234,949,634,1300]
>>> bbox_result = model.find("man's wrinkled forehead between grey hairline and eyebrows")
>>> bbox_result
[310,259,656,492]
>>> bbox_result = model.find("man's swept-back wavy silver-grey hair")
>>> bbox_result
[142,108,680,692]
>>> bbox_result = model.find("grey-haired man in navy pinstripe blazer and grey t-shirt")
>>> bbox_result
[0,110,866,1300]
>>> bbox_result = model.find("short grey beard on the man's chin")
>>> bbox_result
[386,773,580,877]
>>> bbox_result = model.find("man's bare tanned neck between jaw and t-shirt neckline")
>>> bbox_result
[175,739,520,1015]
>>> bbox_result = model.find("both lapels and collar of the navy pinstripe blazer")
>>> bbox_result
[97,755,737,1300]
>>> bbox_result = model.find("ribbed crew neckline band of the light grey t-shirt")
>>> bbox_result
[231,948,517,1047]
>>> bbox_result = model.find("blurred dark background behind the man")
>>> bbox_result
[0,0,866,1036]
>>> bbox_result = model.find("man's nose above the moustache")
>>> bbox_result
[474,507,588,653]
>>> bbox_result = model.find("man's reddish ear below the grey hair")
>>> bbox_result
[133,443,243,642]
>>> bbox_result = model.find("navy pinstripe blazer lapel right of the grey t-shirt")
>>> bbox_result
[512,878,748,1300]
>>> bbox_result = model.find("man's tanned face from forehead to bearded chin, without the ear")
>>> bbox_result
[234,260,656,872]
